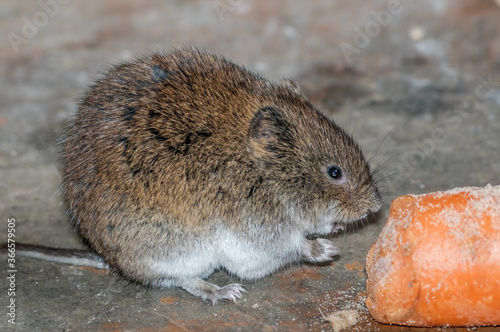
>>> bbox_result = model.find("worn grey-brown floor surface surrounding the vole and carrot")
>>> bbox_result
[0,0,500,331]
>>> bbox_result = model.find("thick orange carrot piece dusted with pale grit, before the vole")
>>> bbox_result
[366,185,500,326]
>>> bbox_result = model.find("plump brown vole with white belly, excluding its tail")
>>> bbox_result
[12,49,381,303]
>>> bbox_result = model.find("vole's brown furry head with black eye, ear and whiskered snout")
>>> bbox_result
[247,82,381,234]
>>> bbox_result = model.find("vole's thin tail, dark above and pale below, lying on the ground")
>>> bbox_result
[0,242,109,269]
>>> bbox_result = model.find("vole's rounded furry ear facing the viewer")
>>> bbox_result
[248,107,287,158]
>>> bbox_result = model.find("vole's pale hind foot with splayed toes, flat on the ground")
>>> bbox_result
[181,277,246,305]
